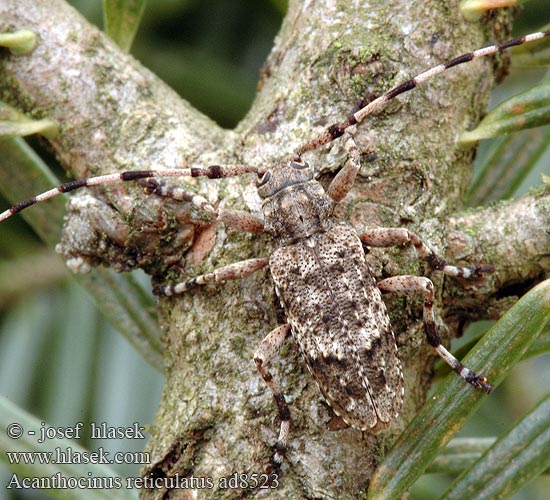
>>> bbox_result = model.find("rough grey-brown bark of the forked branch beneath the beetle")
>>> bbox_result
[0,0,550,499]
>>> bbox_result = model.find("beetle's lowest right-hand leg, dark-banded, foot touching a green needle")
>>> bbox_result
[377,276,492,393]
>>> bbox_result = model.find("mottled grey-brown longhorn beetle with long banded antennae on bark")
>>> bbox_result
[0,31,550,468]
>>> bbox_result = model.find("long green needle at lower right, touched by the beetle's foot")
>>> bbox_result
[368,280,550,500]
